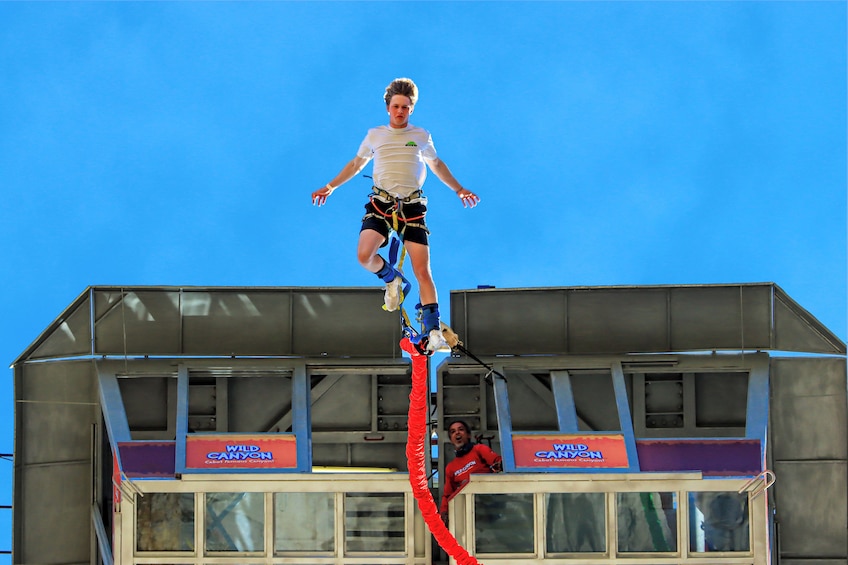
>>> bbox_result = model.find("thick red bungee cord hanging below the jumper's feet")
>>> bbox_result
[400,337,481,565]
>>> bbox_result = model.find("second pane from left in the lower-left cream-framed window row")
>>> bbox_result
[206,492,265,551]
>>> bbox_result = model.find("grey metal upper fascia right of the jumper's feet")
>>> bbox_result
[451,283,845,355]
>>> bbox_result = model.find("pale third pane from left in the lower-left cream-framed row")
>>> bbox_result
[274,492,335,553]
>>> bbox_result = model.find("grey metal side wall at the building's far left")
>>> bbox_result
[13,362,100,564]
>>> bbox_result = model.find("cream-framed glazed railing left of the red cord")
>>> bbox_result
[114,473,431,565]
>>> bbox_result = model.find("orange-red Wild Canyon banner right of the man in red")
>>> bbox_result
[512,434,630,469]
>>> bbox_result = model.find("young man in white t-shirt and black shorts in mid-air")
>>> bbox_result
[312,78,480,353]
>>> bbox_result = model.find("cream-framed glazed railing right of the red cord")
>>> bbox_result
[449,473,769,565]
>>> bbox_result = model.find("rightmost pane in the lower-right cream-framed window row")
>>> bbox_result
[689,492,751,553]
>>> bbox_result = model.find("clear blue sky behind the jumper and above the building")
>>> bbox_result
[0,1,847,563]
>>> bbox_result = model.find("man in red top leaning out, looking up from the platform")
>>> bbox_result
[439,420,503,522]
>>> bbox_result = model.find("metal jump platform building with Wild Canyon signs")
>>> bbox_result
[13,283,848,565]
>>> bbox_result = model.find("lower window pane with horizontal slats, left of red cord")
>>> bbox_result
[345,492,406,553]
